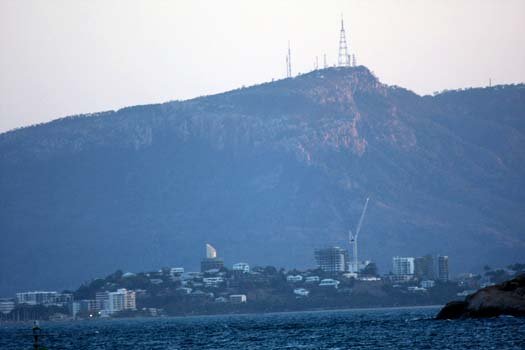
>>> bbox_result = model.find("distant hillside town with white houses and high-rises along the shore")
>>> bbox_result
[0,244,525,322]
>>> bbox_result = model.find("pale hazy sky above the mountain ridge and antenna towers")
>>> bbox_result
[0,0,525,132]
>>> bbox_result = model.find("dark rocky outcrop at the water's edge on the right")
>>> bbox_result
[436,274,525,320]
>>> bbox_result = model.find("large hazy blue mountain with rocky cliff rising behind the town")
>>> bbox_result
[0,66,525,294]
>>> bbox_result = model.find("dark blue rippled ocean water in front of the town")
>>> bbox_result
[0,308,525,350]
